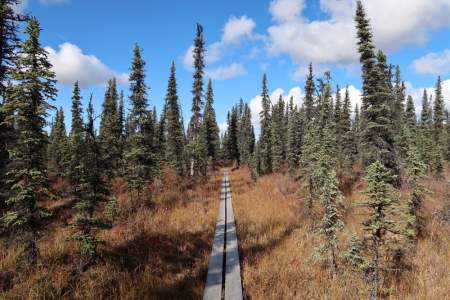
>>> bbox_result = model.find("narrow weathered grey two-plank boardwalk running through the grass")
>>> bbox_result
[203,169,242,300]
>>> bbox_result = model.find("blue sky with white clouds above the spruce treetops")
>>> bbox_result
[22,0,450,131]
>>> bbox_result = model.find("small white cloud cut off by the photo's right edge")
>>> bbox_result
[411,49,450,75]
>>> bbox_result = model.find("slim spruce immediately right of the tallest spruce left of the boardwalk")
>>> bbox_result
[203,79,219,164]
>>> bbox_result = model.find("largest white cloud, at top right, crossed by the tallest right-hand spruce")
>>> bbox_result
[268,0,450,64]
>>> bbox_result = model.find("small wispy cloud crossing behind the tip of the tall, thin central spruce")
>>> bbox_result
[183,16,256,70]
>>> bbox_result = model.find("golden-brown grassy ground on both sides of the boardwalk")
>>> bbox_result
[0,168,450,299]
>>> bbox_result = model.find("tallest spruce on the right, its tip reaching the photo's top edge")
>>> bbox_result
[355,1,400,185]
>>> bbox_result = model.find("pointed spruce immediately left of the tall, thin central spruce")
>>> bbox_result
[166,62,185,176]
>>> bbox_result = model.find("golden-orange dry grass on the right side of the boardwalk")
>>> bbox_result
[231,165,450,299]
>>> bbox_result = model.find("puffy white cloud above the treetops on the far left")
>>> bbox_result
[45,43,128,86]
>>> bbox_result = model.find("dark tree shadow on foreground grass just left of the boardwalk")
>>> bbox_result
[105,232,212,299]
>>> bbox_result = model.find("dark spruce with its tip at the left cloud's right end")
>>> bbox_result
[99,78,121,177]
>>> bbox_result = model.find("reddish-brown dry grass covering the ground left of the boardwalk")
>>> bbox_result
[0,173,221,299]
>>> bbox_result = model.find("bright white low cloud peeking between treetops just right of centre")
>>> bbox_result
[249,86,303,129]
